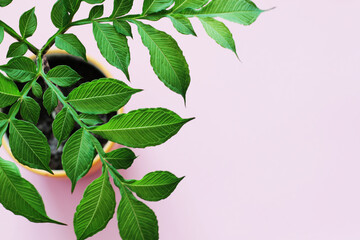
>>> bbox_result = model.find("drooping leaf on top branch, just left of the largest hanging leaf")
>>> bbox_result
[93,22,130,79]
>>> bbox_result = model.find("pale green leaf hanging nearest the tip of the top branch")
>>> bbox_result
[199,17,237,56]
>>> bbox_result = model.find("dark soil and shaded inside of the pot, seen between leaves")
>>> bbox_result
[3,54,116,170]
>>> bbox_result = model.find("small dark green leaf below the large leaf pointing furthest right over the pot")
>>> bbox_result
[105,148,136,169]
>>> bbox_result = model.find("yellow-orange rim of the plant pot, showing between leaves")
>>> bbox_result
[3,49,124,178]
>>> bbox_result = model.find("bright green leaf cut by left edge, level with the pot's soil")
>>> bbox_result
[0,73,20,108]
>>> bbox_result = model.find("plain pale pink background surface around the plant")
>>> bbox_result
[0,0,360,240]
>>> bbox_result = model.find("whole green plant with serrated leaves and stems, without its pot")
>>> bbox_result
[0,0,262,240]
